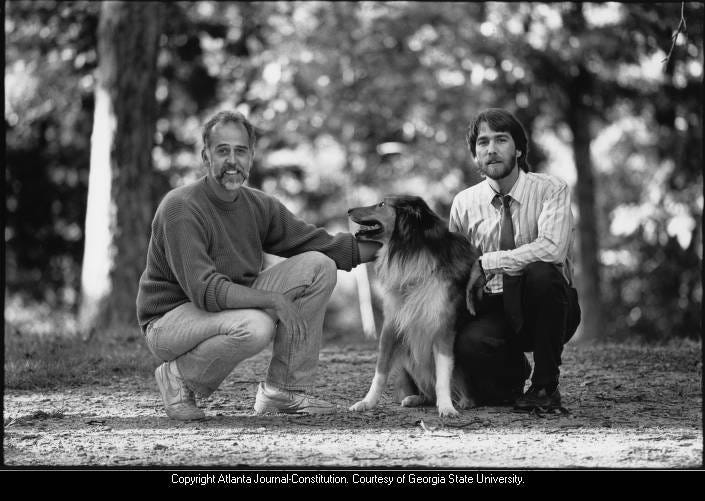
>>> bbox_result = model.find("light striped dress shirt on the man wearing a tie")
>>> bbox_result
[449,170,575,294]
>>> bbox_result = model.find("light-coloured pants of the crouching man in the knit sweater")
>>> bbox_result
[146,252,337,396]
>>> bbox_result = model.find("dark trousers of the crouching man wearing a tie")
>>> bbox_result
[455,262,580,404]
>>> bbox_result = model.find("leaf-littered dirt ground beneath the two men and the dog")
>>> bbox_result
[3,343,703,469]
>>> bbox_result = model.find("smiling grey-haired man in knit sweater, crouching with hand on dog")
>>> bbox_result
[137,111,378,420]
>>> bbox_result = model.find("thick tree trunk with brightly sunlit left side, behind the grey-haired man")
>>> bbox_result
[79,1,164,338]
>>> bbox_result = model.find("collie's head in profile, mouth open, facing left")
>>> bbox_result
[348,195,446,244]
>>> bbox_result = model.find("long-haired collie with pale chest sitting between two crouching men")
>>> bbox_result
[348,196,484,417]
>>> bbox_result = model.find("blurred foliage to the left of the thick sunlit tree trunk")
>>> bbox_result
[5,2,99,305]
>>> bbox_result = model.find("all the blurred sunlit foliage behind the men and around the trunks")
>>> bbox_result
[5,1,703,339]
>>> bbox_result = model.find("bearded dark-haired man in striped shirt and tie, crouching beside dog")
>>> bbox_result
[449,108,580,410]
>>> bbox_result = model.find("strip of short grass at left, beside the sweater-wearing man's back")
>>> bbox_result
[4,323,156,389]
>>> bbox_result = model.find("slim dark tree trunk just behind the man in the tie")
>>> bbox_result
[568,66,604,341]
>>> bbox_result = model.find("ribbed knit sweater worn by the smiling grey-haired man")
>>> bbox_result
[137,176,360,332]
